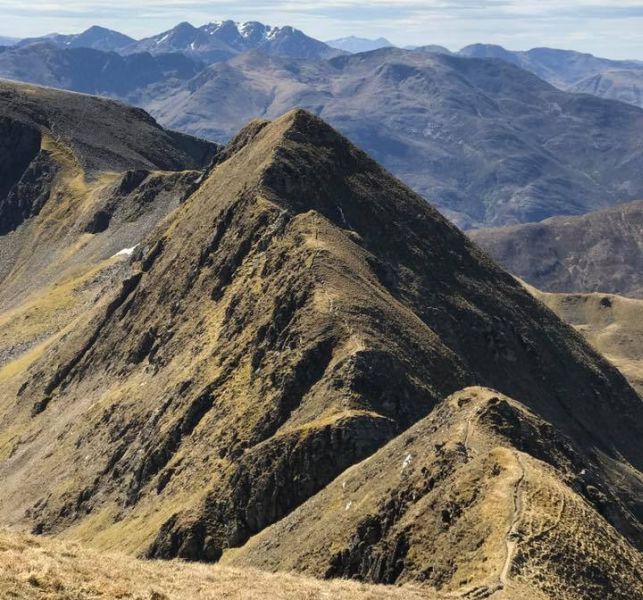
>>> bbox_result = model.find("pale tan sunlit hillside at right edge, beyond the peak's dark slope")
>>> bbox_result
[528,286,643,396]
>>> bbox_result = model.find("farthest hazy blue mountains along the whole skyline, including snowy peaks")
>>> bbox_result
[5,20,643,108]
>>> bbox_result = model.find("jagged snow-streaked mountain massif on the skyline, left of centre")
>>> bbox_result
[124,21,341,62]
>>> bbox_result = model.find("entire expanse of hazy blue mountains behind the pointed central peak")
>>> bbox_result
[0,21,643,226]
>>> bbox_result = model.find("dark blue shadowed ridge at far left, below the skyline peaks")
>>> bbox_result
[0,43,203,103]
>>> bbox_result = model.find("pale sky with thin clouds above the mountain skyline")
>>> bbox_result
[0,0,643,60]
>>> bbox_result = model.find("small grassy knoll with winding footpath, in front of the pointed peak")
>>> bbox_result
[230,388,643,600]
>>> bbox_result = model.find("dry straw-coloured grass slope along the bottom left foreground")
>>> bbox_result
[0,531,427,600]
